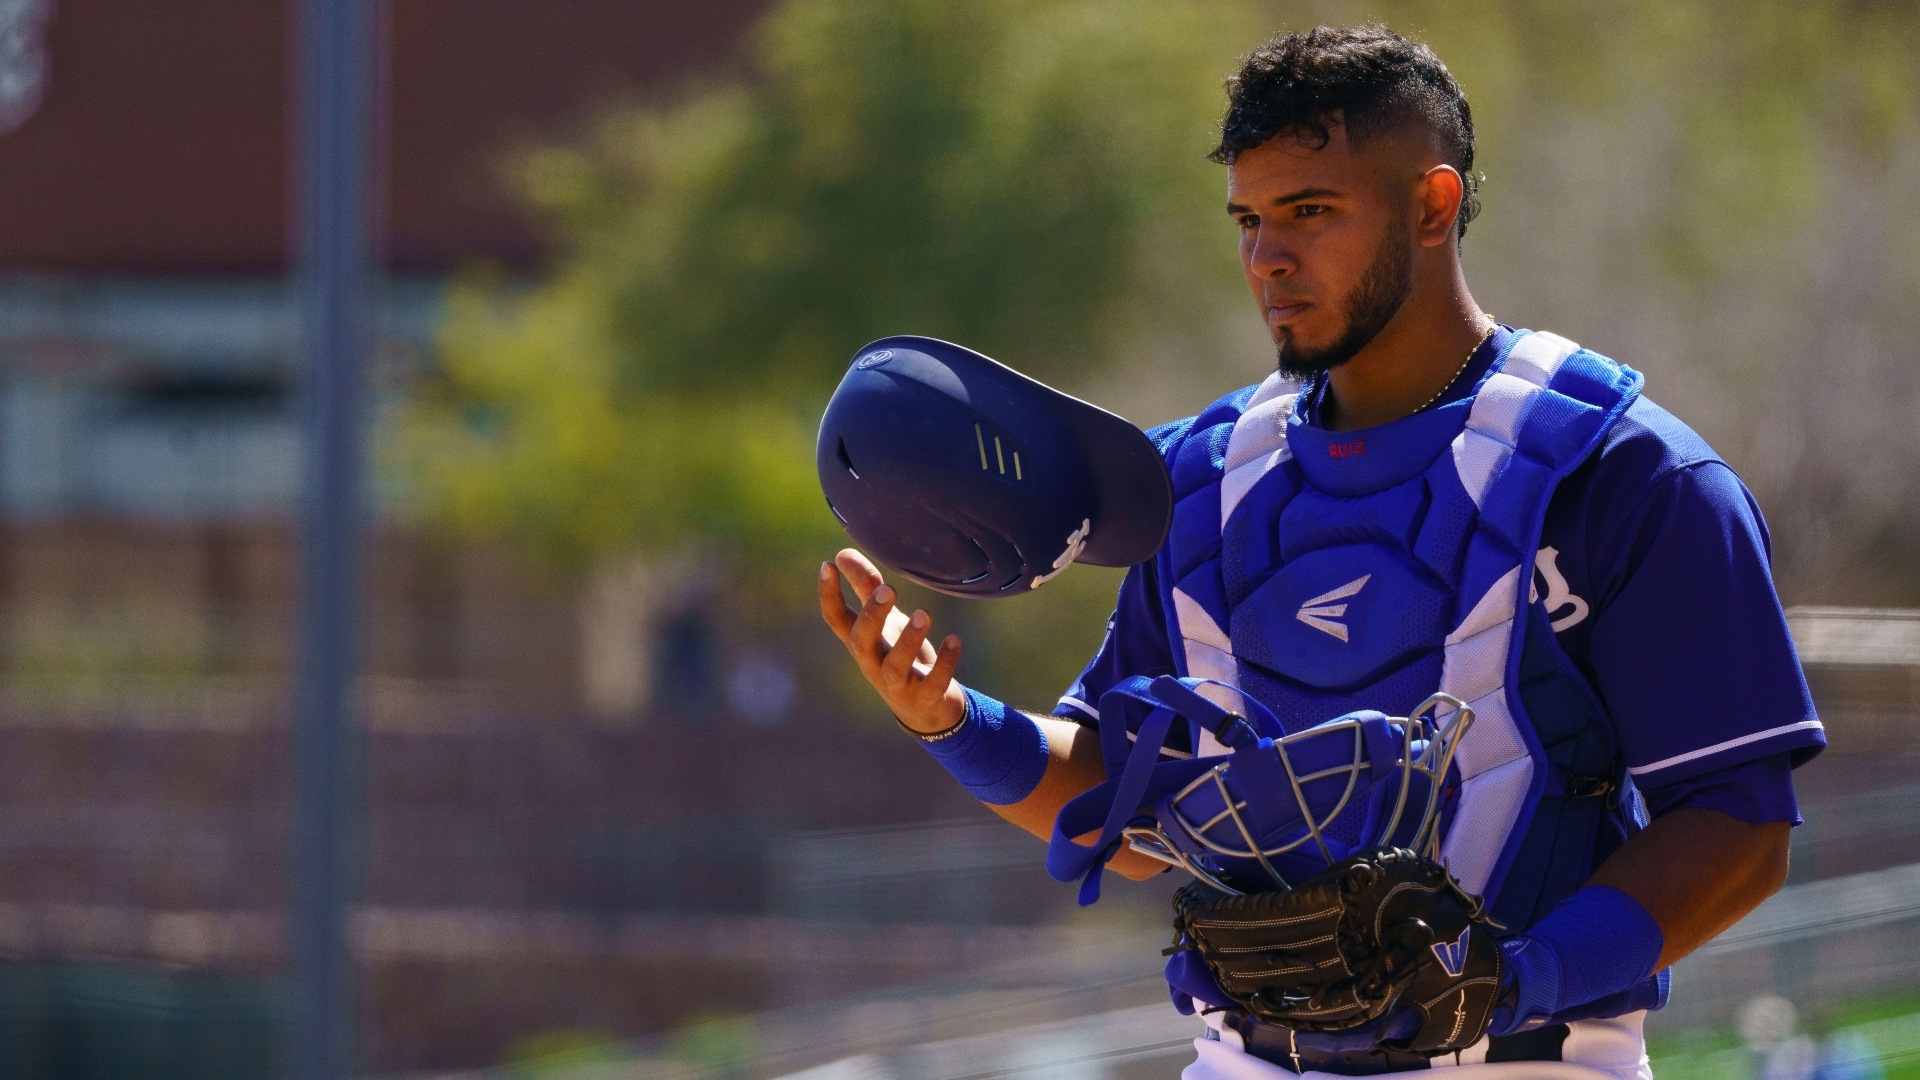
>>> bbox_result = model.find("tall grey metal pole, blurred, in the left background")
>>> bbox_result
[288,0,372,1080]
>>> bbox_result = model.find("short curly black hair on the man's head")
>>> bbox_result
[1208,25,1482,236]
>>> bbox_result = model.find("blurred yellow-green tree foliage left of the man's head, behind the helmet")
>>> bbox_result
[390,0,1258,592]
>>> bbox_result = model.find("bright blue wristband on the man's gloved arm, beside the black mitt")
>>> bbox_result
[1490,886,1667,1036]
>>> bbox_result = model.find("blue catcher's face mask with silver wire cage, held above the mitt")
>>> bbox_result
[1048,676,1473,903]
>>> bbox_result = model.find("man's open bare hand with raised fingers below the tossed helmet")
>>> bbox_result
[820,548,966,734]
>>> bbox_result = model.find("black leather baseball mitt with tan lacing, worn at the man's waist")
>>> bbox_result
[1173,847,1503,1057]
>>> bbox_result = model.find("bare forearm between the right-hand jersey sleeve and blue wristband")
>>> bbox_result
[1588,809,1791,969]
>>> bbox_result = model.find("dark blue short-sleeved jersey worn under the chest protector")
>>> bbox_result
[1054,329,1824,822]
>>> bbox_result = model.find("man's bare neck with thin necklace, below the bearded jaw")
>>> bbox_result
[1319,261,1490,430]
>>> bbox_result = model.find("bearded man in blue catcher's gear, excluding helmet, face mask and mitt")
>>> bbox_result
[820,27,1824,1080]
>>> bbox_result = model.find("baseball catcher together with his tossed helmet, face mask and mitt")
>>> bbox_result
[816,27,1824,1080]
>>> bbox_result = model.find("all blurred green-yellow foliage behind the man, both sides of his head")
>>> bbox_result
[386,0,1920,722]
